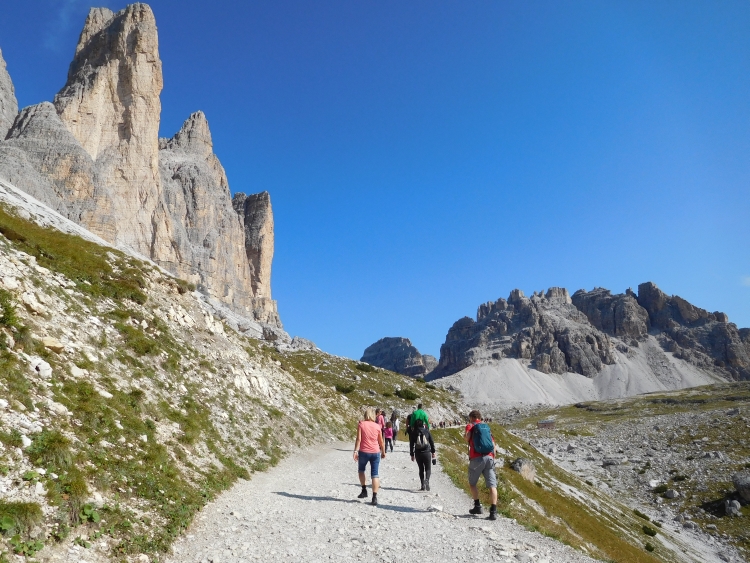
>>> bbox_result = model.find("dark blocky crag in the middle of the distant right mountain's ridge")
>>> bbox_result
[572,287,650,341]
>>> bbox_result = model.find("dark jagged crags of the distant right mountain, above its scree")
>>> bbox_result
[431,282,750,381]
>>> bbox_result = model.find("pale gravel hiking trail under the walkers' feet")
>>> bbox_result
[168,441,594,563]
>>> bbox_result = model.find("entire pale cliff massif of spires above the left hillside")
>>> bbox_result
[0,4,281,326]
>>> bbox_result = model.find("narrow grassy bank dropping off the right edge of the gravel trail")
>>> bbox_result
[434,424,670,563]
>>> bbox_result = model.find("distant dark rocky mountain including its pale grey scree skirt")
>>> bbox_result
[429,282,750,404]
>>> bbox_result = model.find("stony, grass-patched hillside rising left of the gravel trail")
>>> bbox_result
[0,182,456,562]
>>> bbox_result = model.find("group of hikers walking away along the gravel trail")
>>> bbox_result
[353,403,497,520]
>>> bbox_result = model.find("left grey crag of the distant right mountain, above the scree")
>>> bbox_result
[433,288,615,377]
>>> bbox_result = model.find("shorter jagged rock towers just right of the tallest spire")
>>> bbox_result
[159,111,280,325]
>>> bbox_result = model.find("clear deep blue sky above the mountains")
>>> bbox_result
[0,0,750,357]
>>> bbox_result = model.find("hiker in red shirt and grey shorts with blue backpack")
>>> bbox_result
[464,410,497,520]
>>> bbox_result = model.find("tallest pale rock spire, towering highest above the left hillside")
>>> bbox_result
[55,4,168,256]
